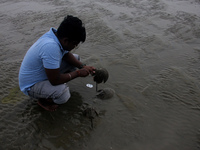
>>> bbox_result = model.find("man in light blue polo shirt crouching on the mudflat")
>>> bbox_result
[19,16,95,111]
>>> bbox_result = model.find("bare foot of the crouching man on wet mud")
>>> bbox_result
[38,99,59,111]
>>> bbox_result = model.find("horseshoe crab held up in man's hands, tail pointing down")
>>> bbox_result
[94,68,109,91]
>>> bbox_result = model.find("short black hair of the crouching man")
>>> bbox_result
[57,15,86,42]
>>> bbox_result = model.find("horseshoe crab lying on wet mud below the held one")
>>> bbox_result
[96,88,115,100]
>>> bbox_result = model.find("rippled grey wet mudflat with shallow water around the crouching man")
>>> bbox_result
[0,0,200,150]
